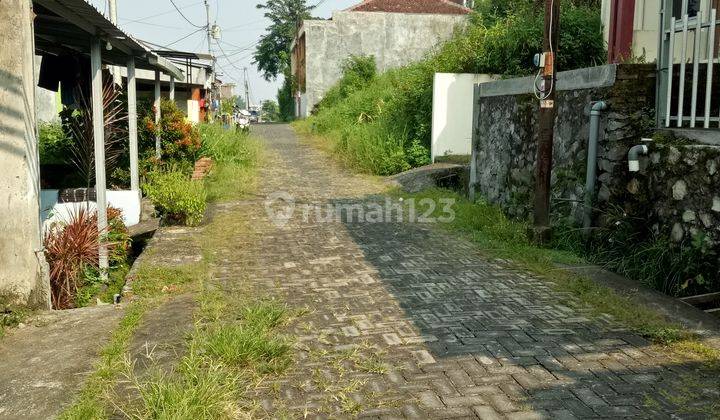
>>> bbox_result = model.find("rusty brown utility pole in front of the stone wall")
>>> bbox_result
[533,0,560,243]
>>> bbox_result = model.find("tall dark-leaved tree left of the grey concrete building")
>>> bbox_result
[253,0,314,81]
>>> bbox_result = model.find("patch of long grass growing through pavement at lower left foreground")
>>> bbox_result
[126,285,292,419]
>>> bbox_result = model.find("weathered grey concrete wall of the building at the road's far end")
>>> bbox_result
[302,11,467,116]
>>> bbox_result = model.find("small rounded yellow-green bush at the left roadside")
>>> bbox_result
[143,171,206,226]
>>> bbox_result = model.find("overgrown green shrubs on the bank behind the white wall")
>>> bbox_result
[299,0,605,175]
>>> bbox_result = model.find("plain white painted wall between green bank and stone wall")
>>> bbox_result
[431,73,497,162]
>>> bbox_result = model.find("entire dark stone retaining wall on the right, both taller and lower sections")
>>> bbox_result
[470,65,720,262]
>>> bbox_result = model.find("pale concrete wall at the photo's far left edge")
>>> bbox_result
[0,0,50,307]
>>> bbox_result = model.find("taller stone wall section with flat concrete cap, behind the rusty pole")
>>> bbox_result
[471,65,655,221]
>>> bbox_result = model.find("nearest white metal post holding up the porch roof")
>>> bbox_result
[90,38,109,279]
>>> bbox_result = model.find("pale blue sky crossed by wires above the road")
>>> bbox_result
[88,0,360,102]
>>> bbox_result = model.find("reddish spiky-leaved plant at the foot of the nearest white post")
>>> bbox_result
[44,207,129,309]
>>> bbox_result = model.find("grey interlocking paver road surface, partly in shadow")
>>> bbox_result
[231,125,713,419]
